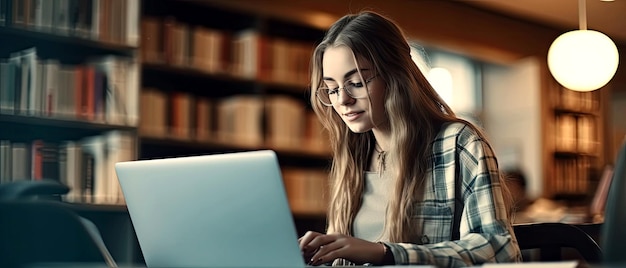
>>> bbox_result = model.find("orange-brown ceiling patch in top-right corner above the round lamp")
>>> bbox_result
[458,0,626,45]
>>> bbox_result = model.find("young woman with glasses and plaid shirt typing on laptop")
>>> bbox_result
[299,9,521,267]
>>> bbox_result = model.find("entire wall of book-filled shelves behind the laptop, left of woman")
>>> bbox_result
[0,0,330,264]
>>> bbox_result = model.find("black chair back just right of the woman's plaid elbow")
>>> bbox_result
[513,222,602,264]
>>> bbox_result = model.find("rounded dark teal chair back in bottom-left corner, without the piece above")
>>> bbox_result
[0,201,111,267]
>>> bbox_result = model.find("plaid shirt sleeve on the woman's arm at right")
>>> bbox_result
[388,126,521,267]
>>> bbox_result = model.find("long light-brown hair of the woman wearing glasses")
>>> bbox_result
[311,11,506,242]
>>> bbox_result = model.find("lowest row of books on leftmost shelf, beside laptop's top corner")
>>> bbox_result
[0,130,136,204]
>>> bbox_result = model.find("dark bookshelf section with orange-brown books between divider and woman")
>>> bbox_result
[139,0,330,237]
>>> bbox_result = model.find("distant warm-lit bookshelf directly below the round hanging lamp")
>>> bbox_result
[545,76,604,205]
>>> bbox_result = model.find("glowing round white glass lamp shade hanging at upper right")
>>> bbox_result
[548,30,619,91]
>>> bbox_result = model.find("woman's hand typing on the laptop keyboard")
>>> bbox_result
[298,231,385,265]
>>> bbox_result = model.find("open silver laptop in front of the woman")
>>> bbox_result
[115,150,305,267]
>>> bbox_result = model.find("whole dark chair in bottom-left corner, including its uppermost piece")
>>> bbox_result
[0,181,116,267]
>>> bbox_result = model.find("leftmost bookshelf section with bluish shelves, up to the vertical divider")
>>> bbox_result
[0,0,140,264]
